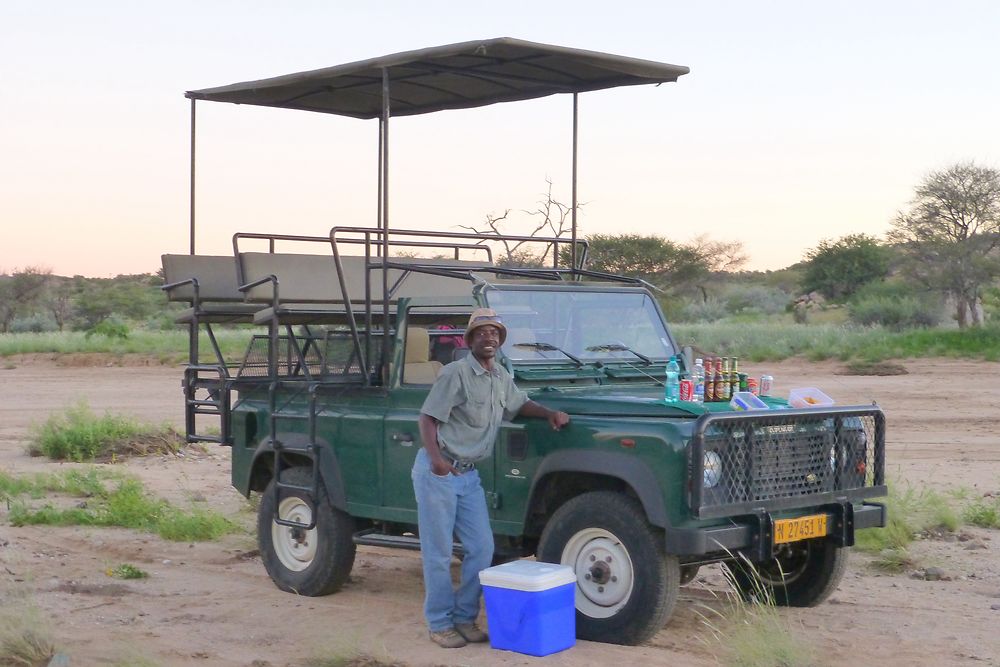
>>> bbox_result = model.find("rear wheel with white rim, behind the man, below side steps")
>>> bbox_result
[257,466,357,597]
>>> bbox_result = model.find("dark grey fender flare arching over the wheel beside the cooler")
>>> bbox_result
[529,449,670,528]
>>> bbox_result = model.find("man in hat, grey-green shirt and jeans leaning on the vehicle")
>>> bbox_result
[412,308,569,648]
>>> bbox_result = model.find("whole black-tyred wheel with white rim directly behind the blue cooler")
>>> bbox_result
[538,491,680,645]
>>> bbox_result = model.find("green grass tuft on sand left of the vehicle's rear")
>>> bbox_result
[28,403,184,462]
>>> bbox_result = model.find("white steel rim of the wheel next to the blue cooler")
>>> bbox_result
[560,528,635,618]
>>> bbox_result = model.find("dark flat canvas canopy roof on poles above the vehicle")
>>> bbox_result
[186,37,690,118]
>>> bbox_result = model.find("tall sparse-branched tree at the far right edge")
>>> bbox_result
[890,162,1000,328]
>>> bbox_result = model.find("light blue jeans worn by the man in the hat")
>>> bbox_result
[411,448,493,632]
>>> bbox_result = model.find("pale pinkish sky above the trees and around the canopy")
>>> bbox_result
[0,0,1000,277]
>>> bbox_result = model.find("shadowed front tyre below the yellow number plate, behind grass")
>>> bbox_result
[726,539,848,607]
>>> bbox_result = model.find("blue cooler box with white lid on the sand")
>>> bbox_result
[479,560,576,656]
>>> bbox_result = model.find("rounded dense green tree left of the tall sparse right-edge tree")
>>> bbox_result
[802,234,889,300]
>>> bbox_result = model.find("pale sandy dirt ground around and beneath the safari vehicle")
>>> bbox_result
[0,357,1000,667]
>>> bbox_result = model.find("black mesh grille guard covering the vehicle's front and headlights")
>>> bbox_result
[688,407,887,519]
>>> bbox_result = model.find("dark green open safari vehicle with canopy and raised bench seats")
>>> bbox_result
[163,39,886,644]
